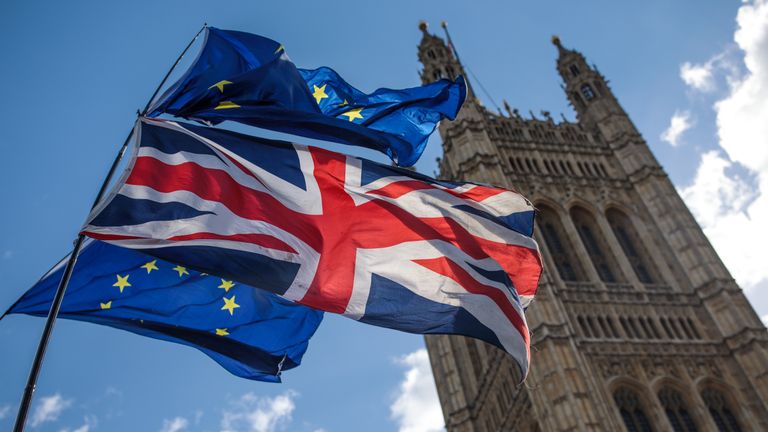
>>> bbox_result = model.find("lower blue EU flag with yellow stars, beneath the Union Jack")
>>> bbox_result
[6,241,323,382]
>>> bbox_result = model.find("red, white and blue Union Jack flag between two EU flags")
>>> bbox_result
[83,118,541,376]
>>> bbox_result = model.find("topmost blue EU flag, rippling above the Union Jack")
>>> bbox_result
[149,27,466,166]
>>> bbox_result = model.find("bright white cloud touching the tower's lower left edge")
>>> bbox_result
[389,348,444,432]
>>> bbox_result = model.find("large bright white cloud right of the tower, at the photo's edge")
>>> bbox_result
[681,0,768,294]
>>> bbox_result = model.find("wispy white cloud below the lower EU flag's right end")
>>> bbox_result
[221,390,297,432]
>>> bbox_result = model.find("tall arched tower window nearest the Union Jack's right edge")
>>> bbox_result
[536,206,584,282]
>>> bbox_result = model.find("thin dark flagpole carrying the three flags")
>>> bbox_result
[13,23,208,432]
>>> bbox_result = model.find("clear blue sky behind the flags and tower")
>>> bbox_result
[0,0,768,432]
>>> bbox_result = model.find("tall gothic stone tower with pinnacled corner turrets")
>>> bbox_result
[419,24,768,432]
